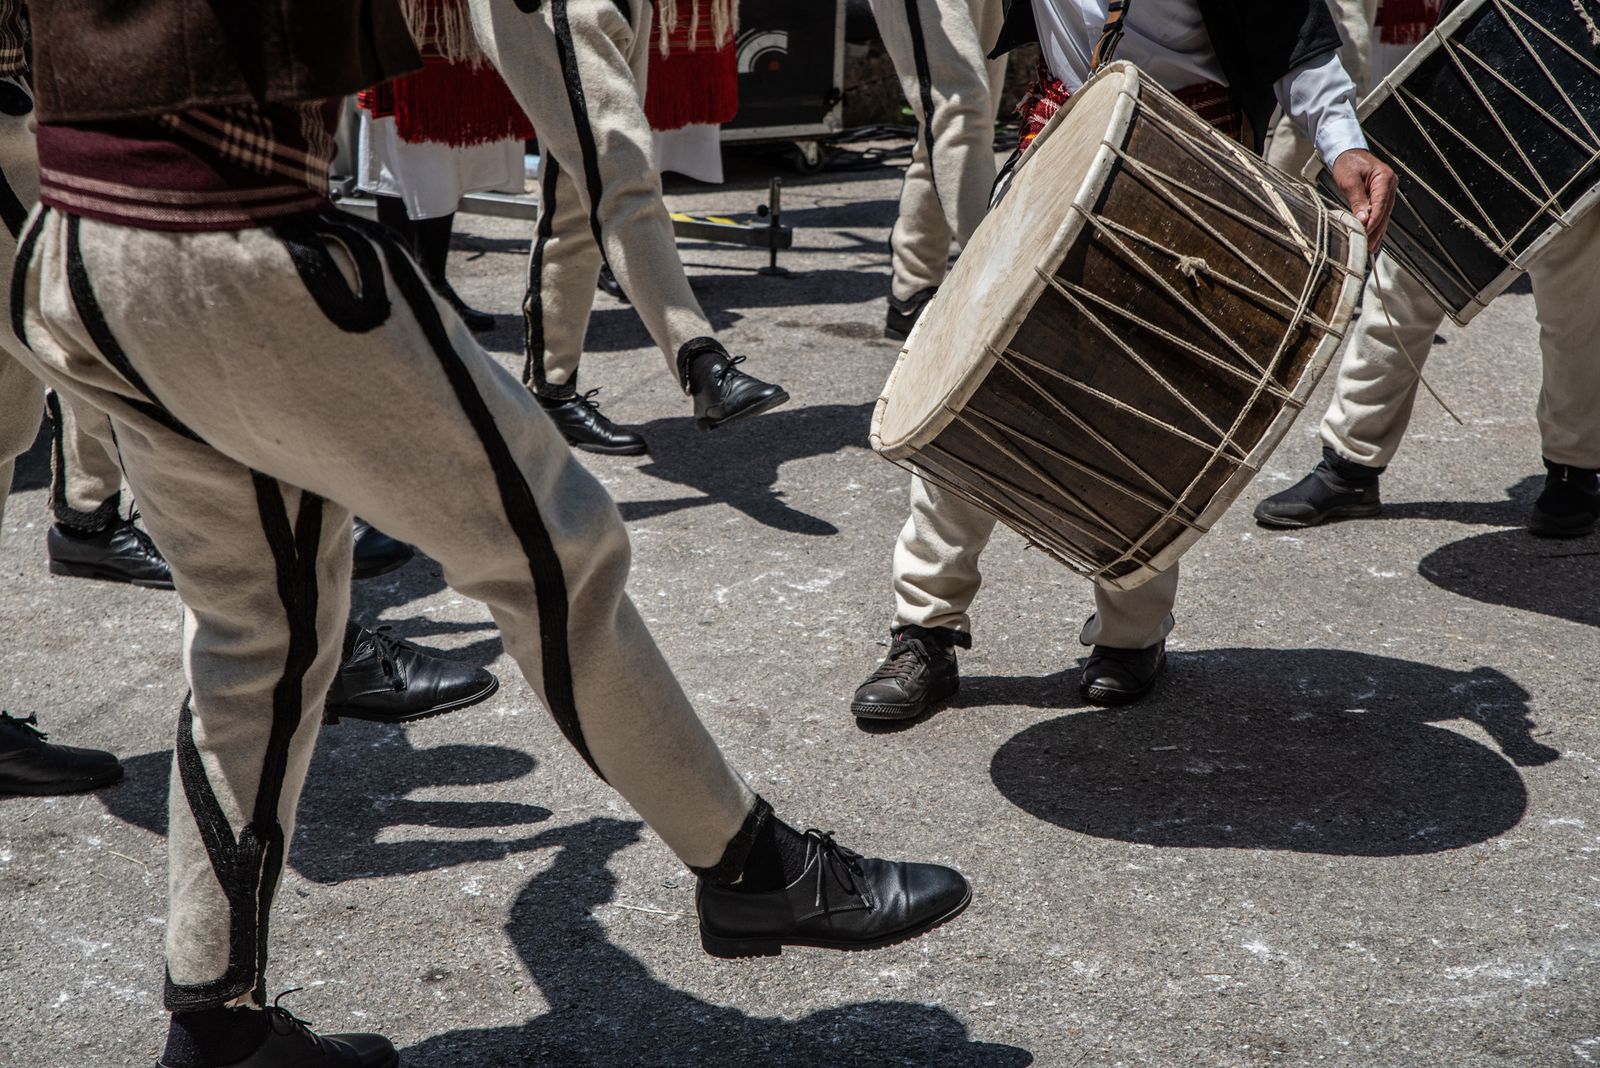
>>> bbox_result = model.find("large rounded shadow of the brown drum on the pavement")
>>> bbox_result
[990,649,1558,857]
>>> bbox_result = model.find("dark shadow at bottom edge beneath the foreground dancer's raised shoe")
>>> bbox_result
[403,819,1034,1068]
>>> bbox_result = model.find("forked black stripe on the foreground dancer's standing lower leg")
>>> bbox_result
[166,482,323,1012]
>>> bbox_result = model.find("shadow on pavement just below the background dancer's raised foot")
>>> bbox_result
[618,404,872,537]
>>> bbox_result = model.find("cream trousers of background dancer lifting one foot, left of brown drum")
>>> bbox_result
[470,0,714,397]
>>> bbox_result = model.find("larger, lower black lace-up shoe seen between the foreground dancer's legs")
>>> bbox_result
[323,624,499,723]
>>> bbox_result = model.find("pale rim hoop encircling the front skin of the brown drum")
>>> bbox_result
[869,59,1147,460]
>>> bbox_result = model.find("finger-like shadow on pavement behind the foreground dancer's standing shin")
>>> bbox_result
[94,729,550,883]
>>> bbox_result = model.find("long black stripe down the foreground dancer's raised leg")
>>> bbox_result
[275,213,605,780]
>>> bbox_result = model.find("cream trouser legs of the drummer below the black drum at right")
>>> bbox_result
[1322,211,1600,470]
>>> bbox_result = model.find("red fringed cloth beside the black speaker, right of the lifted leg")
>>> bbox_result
[645,0,739,130]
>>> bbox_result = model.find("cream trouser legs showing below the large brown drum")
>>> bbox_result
[894,476,1178,649]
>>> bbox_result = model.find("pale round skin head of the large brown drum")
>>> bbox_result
[874,62,1139,459]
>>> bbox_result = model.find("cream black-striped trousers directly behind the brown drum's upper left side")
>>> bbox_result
[872,0,1005,301]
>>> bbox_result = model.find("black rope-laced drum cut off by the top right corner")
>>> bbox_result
[1307,0,1600,323]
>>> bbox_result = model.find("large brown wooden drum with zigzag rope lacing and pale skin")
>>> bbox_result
[872,62,1366,588]
